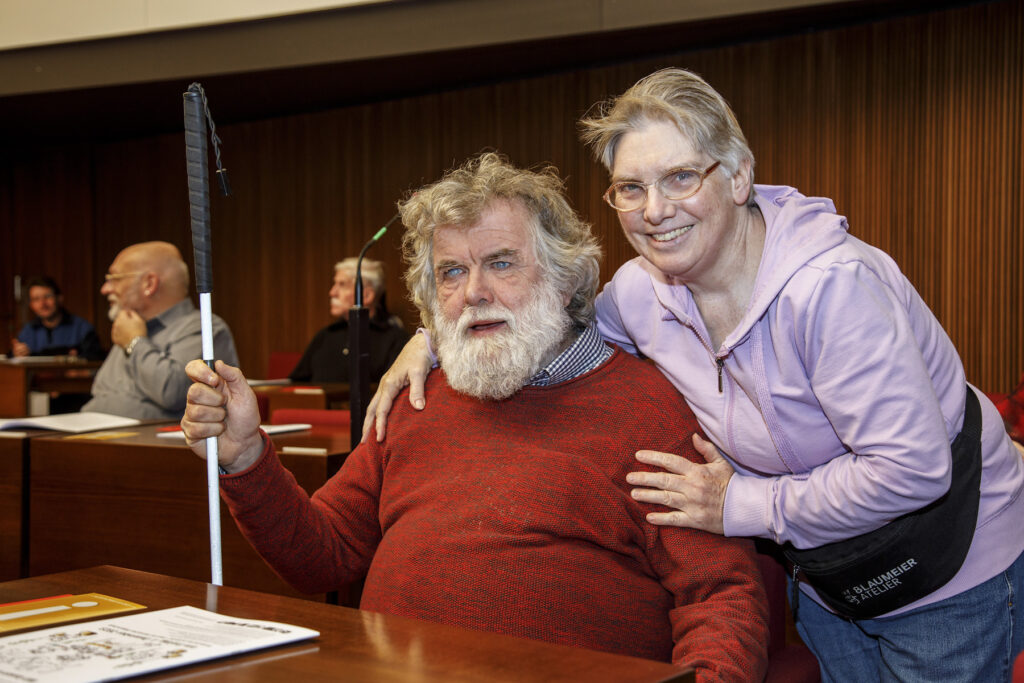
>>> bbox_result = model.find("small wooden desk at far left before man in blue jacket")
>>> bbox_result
[0,355,102,418]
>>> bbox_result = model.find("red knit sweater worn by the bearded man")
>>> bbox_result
[222,351,768,681]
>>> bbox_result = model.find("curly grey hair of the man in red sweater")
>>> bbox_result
[398,153,601,329]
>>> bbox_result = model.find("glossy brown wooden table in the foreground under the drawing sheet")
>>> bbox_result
[0,566,694,683]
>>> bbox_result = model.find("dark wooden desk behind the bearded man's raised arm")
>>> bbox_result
[29,425,349,600]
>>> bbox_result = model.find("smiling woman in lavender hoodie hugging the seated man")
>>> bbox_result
[371,69,1024,682]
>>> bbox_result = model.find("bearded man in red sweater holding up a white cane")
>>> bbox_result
[181,154,767,681]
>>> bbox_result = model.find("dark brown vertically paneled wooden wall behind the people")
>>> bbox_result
[0,0,1024,391]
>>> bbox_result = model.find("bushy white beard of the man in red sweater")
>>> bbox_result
[433,284,572,400]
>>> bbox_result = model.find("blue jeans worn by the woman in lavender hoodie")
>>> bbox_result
[797,554,1024,683]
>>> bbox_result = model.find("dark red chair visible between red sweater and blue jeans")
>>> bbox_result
[757,553,823,683]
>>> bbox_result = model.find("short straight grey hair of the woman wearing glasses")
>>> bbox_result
[580,69,754,192]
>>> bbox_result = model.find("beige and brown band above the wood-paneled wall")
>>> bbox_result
[0,0,856,97]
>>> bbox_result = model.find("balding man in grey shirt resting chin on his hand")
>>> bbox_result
[82,242,239,420]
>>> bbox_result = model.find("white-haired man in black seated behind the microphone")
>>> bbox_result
[288,258,409,382]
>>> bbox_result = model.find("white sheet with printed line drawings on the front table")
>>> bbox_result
[0,605,319,683]
